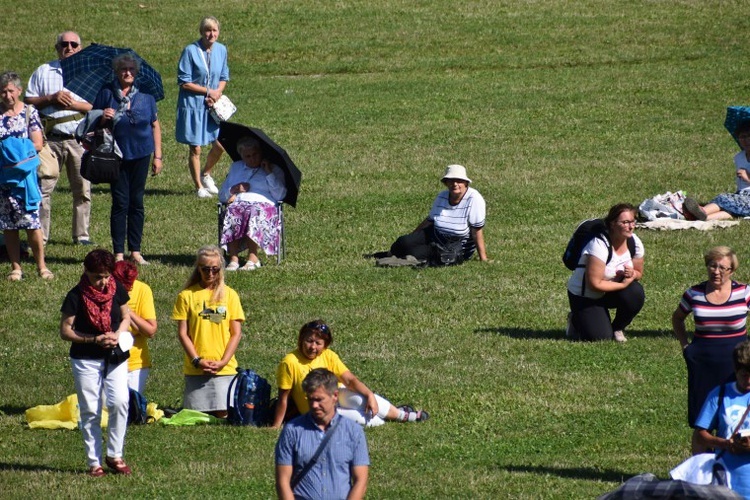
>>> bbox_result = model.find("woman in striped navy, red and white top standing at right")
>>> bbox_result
[672,246,750,453]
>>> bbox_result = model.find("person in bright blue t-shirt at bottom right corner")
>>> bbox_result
[693,341,750,498]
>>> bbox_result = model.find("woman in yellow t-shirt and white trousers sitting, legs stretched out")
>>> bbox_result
[273,320,429,428]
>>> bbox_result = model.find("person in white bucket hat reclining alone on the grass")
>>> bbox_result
[390,165,487,266]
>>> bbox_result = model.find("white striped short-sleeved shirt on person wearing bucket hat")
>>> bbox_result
[427,188,485,238]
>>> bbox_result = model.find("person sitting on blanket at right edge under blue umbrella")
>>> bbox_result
[683,122,750,220]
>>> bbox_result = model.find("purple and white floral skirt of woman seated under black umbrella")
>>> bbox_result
[221,201,281,255]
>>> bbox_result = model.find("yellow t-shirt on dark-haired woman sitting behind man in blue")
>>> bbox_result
[276,349,349,413]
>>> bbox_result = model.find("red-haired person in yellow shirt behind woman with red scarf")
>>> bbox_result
[112,260,158,394]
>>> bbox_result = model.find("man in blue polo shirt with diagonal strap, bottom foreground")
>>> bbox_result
[276,368,370,500]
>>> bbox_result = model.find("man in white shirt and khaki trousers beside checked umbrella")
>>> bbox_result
[24,31,93,245]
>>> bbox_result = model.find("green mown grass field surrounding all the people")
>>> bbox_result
[0,0,750,498]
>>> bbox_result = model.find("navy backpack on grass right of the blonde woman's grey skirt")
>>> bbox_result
[227,368,273,427]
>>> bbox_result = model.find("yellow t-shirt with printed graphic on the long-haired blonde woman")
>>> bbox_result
[172,284,245,375]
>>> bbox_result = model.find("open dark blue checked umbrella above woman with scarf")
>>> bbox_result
[60,43,164,102]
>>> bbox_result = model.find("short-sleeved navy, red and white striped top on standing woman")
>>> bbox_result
[680,281,750,339]
